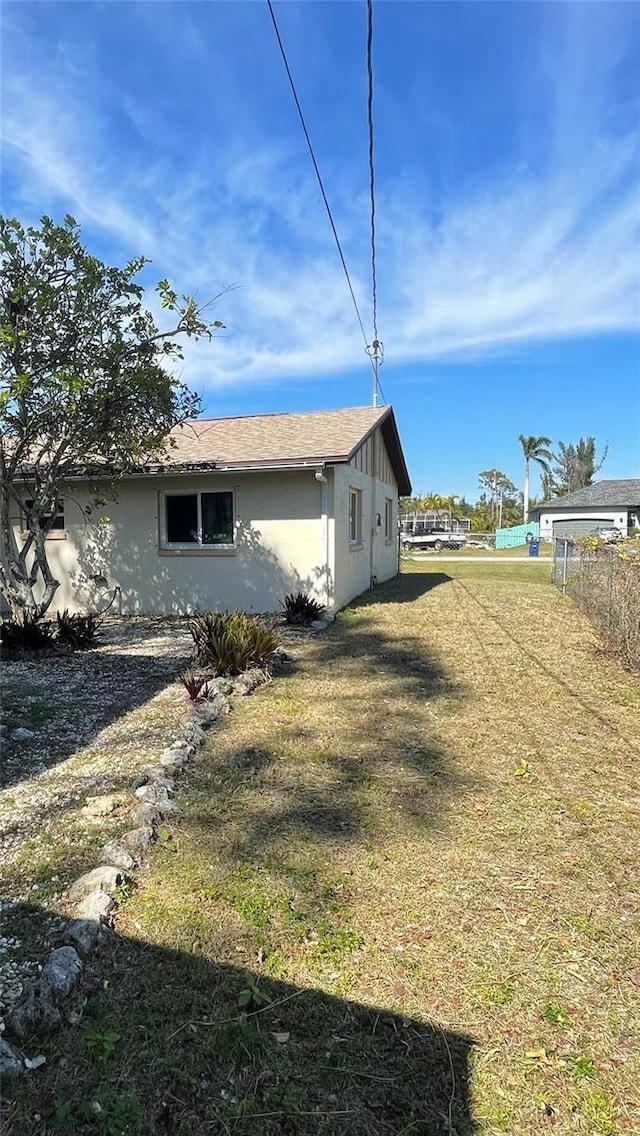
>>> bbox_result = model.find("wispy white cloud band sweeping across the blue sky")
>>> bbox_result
[2,11,640,389]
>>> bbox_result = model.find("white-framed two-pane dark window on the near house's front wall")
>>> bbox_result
[161,492,233,549]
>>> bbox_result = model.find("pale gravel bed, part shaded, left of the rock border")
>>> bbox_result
[0,618,190,881]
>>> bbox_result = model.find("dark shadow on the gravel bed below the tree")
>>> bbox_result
[0,636,189,792]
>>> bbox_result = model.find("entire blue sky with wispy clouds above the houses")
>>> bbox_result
[1,0,640,499]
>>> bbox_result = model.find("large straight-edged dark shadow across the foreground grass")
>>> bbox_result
[2,899,476,1136]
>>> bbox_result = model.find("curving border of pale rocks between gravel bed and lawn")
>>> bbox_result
[0,658,295,1076]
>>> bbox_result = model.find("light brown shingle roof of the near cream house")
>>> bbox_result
[168,407,388,468]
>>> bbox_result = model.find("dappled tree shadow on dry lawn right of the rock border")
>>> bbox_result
[183,607,477,877]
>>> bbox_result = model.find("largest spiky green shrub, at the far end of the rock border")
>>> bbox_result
[189,611,280,675]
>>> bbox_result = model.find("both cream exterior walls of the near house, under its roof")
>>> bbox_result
[5,431,398,615]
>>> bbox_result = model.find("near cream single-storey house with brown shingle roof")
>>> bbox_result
[11,407,412,615]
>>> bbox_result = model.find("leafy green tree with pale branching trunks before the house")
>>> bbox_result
[0,217,223,618]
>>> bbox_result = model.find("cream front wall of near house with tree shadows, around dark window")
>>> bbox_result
[10,469,334,615]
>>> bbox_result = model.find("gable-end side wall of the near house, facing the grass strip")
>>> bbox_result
[334,431,398,609]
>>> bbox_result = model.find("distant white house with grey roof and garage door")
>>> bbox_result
[531,478,640,541]
